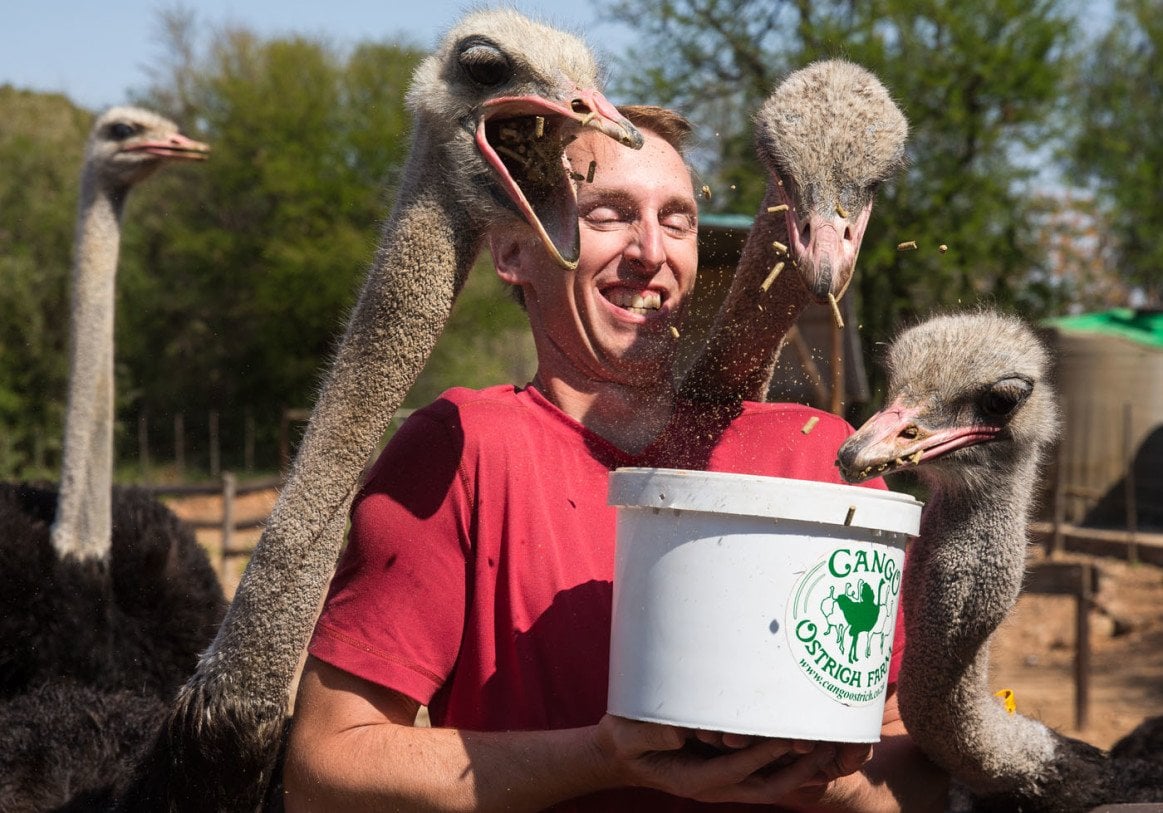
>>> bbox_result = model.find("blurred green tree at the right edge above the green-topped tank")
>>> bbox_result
[1070,0,1163,307]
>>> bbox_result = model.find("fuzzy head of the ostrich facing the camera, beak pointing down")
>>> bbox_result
[755,59,908,301]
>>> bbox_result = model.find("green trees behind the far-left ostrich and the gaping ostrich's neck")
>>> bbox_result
[0,9,531,477]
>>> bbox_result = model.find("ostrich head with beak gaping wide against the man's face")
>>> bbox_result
[408,9,643,268]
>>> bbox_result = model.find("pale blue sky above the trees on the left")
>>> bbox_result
[0,0,629,110]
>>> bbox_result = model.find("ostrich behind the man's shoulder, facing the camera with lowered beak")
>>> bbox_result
[682,59,908,405]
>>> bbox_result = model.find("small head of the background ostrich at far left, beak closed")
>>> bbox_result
[85,107,211,190]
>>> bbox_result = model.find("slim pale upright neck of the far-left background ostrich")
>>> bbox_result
[51,173,124,559]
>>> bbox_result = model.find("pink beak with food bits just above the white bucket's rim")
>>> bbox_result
[836,400,1000,483]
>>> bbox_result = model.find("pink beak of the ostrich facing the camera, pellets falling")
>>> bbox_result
[776,183,872,302]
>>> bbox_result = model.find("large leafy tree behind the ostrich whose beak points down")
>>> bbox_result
[608,0,1073,397]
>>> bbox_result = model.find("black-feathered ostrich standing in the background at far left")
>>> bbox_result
[0,107,226,699]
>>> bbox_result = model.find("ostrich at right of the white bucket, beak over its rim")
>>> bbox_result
[837,312,1163,813]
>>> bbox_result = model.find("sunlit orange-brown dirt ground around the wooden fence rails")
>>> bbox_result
[170,491,1163,748]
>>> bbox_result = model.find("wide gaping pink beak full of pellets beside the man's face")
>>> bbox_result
[476,88,644,269]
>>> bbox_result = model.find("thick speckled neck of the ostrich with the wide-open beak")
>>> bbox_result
[192,130,483,707]
